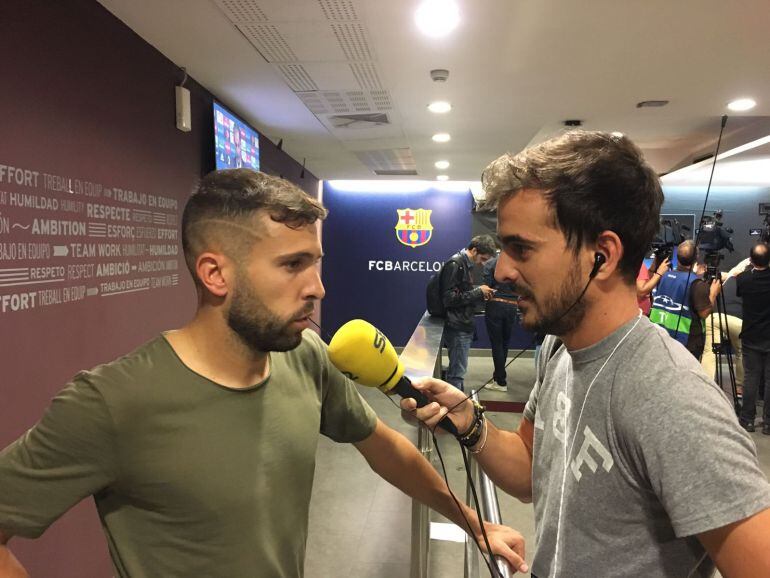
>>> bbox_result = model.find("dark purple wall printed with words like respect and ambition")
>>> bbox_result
[0,0,317,578]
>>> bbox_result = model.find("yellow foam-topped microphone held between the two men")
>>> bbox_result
[329,319,458,435]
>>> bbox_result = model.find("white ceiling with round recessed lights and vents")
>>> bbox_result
[99,0,770,180]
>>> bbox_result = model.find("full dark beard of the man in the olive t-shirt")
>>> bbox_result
[227,274,313,352]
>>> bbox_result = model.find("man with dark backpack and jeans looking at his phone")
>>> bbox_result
[440,235,496,390]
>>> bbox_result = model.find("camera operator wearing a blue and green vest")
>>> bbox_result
[650,240,721,360]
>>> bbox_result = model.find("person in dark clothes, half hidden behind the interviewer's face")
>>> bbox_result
[483,256,518,392]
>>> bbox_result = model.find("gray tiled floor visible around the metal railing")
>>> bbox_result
[305,348,770,578]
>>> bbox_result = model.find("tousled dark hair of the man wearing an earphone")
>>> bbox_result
[481,131,663,283]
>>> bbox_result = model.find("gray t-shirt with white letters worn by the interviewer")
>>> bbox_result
[524,317,770,578]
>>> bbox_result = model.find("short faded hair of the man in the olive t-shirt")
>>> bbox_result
[182,169,327,286]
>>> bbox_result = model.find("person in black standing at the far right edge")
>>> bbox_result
[736,243,770,435]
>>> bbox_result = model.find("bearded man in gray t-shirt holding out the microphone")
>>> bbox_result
[402,131,770,578]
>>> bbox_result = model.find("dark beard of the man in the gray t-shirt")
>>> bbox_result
[516,266,587,336]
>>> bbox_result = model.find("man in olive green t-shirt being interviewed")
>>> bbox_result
[0,169,526,578]
